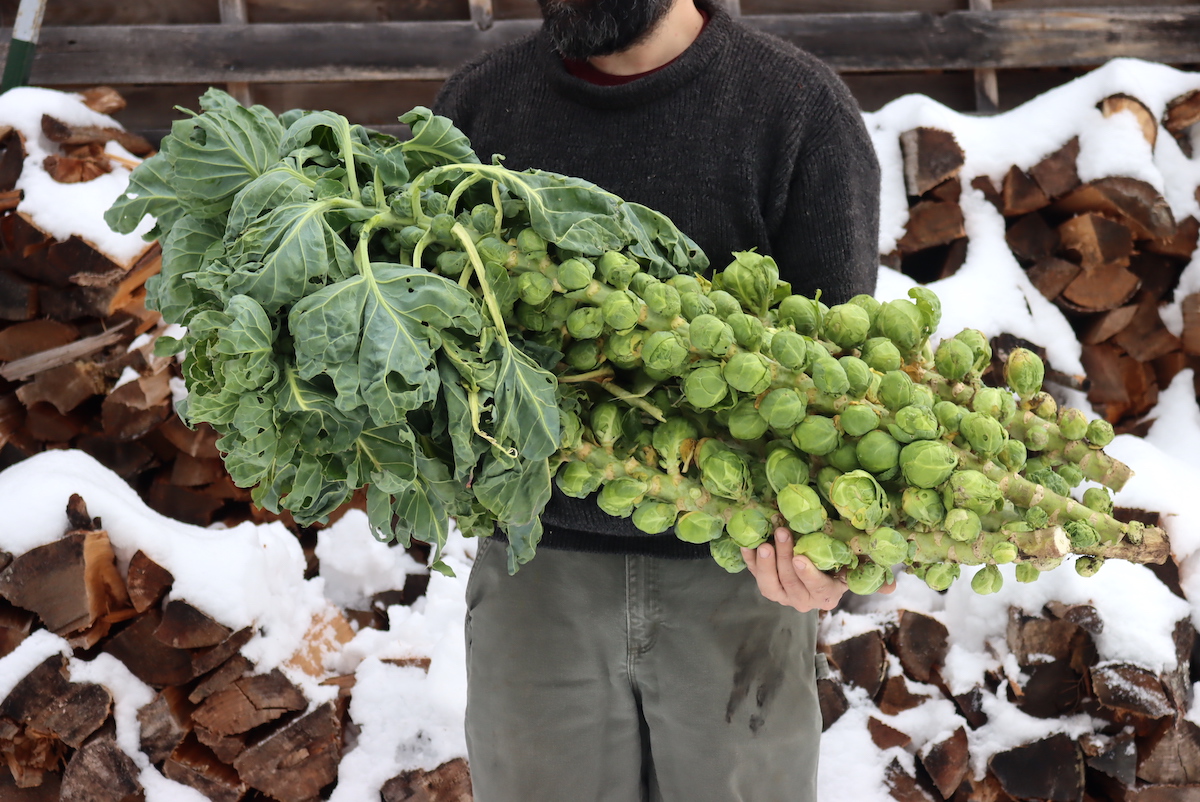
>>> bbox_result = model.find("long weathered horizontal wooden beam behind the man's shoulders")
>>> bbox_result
[0,7,1200,86]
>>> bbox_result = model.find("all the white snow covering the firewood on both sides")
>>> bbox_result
[0,60,1200,802]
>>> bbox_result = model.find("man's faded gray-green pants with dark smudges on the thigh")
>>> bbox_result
[466,538,821,802]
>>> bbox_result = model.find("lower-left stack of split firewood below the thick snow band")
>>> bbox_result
[0,496,470,802]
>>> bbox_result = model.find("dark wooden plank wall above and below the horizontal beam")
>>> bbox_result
[0,0,1200,136]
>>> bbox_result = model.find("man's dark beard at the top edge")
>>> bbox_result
[538,0,672,61]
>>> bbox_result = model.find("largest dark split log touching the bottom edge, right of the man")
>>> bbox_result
[988,732,1084,802]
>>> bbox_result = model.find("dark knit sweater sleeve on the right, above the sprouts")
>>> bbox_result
[772,92,880,304]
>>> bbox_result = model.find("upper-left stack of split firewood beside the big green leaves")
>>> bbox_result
[0,90,285,526]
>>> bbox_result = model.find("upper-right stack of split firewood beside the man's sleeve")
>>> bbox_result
[883,90,1200,432]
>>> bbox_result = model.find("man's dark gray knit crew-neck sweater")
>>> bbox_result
[434,4,880,557]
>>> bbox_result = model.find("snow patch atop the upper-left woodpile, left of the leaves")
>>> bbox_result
[0,86,154,265]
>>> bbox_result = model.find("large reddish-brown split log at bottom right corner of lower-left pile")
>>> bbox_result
[234,702,342,802]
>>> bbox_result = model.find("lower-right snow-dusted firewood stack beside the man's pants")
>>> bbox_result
[818,552,1200,802]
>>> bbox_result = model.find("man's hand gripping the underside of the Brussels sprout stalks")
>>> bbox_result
[742,526,895,612]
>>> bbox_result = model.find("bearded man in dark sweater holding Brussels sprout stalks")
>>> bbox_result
[434,0,878,802]
